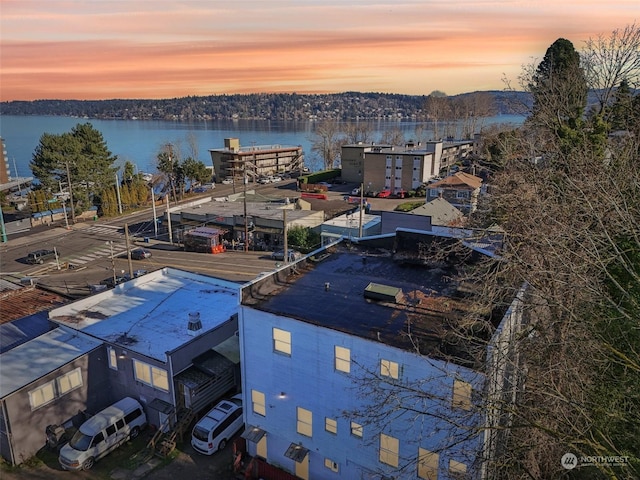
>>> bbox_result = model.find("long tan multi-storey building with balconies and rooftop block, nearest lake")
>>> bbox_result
[209,138,304,184]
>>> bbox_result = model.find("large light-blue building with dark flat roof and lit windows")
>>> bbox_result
[239,231,519,479]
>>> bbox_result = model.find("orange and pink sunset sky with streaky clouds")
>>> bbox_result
[0,0,640,101]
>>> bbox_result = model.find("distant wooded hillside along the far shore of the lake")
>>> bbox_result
[0,91,531,121]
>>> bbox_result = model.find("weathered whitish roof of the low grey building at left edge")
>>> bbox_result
[0,327,102,398]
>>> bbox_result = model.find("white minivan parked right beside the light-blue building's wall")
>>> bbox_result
[191,394,244,455]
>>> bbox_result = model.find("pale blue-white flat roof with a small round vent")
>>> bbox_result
[49,268,240,362]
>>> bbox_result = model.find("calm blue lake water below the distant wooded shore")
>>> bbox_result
[0,115,524,177]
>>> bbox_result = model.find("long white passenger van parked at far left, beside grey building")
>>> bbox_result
[58,397,147,470]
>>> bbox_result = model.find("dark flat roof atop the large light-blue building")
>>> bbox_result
[242,234,498,366]
